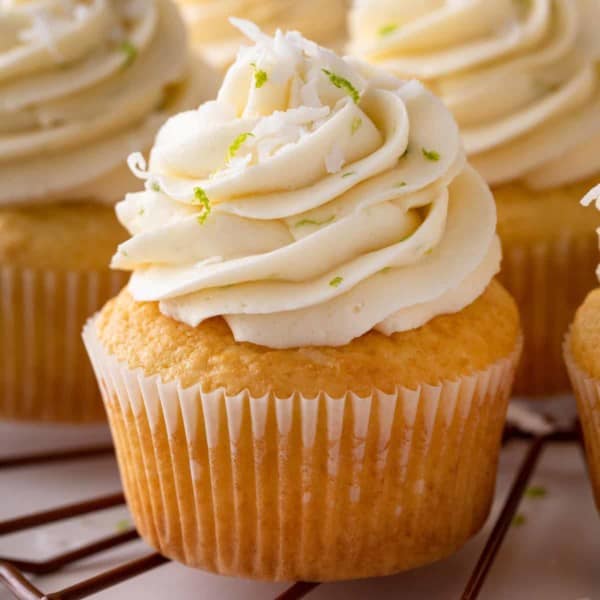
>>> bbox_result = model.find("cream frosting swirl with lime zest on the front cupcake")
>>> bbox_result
[113,21,500,348]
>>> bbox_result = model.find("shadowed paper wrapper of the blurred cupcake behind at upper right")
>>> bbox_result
[499,230,598,396]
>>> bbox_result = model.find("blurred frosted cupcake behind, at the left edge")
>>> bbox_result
[0,0,216,422]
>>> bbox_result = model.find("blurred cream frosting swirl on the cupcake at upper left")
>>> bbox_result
[0,0,216,204]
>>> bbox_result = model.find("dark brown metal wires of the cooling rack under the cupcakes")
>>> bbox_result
[0,425,584,600]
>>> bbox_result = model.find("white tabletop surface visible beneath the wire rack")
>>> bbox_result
[0,424,600,600]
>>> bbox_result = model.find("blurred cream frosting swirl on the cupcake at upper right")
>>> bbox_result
[350,0,600,188]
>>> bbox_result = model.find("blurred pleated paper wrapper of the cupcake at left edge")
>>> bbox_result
[0,266,126,422]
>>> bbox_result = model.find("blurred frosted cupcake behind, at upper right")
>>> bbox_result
[350,0,600,395]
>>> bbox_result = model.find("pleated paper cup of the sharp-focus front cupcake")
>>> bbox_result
[84,321,520,581]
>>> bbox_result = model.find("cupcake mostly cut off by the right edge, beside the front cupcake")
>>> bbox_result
[564,185,600,509]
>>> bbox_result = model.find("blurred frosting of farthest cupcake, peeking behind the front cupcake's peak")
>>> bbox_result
[171,0,347,70]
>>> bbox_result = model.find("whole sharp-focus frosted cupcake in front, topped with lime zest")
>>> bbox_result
[84,21,520,581]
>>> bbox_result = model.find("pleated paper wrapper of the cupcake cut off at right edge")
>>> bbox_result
[564,335,600,510]
